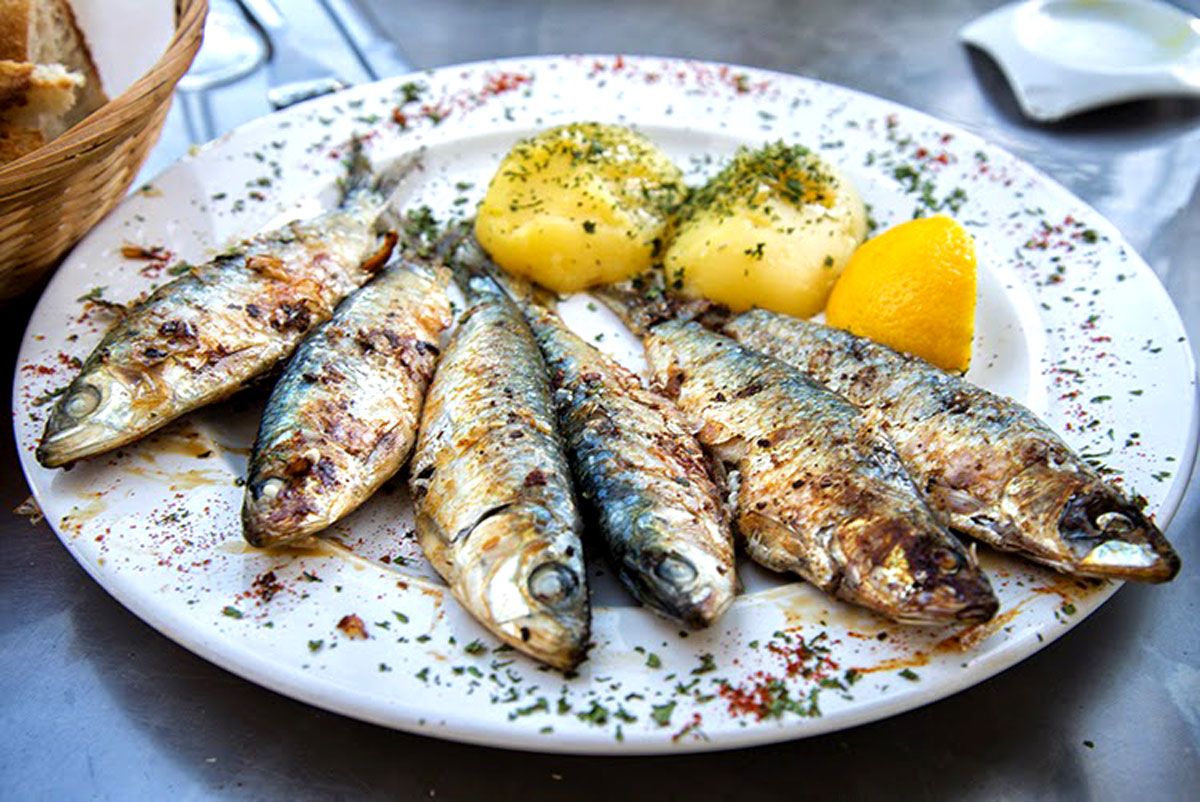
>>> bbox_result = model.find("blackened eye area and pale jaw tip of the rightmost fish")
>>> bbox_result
[1058,485,1181,582]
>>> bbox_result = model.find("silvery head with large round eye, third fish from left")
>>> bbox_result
[451,502,590,669]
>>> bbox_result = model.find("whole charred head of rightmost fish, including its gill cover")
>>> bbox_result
[1001,460,1180,582]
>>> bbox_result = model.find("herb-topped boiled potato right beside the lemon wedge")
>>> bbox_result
[665,143,866,317]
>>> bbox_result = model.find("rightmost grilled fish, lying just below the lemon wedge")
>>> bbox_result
[724,310,1180,582]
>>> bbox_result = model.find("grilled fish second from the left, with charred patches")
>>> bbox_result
[242,263,452,547]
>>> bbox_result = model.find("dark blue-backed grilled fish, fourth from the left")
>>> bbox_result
[523,305,739,628]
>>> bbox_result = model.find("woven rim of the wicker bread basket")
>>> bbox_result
[0,0,208,182]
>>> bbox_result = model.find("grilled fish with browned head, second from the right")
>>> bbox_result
[644,321,998,624]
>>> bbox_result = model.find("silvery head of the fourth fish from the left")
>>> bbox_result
[619,508,739,628]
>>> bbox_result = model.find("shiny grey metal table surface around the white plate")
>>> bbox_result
[0,0,1200,800]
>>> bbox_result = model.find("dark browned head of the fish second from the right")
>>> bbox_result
[842,519,1000,624]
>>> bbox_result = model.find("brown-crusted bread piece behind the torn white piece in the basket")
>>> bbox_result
[0,0,108,130]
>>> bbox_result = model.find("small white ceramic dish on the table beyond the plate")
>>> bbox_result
[959,0,1200,122]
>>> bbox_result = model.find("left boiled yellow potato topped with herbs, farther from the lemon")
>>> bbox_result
[475,122,684,293]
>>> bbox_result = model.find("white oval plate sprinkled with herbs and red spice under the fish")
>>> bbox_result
[13,56,1196,753]
